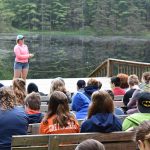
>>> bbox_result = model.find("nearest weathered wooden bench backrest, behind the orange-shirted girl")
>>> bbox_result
[12,131,136,150]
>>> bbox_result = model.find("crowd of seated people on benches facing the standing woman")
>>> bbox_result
[0,72,150,150]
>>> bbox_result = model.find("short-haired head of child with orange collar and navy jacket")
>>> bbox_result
[25,92,41,110]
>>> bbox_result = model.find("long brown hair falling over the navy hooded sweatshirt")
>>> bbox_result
[88,91,114,119]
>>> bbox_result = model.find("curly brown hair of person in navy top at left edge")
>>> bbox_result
[0,87,15,110]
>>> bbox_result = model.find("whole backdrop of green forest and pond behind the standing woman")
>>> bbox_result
[0,0,150,80]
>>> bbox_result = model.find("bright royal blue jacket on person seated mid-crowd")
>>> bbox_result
[72,92,90,119]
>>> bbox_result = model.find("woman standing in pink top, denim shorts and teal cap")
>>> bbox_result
[14,35,34,80]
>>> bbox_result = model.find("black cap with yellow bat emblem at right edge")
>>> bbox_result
[138,92,150,113]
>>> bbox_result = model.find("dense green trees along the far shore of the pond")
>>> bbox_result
[0,0,150,35]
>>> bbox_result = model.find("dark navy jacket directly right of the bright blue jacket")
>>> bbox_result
[83,86,99,100]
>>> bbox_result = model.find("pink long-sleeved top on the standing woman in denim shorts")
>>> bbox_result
[14,44,29,63]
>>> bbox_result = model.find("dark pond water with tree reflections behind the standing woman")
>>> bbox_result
[0,34,150,78]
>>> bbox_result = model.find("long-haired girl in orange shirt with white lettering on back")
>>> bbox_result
[40,91,79,134]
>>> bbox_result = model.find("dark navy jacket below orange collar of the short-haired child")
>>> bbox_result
[27,113,44,124]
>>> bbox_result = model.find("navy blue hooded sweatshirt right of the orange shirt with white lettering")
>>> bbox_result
[81,113,122,133]
